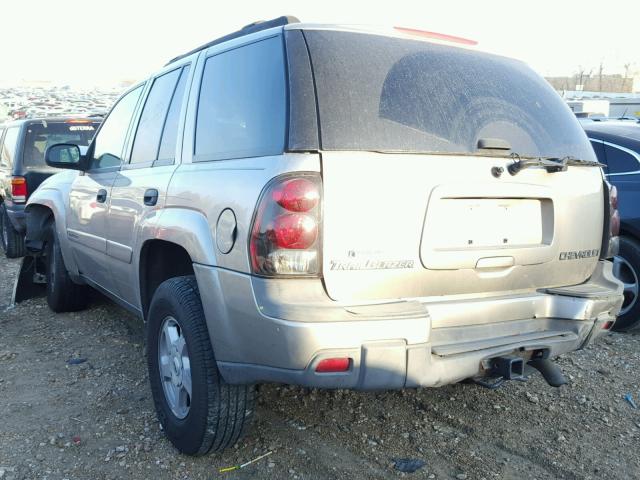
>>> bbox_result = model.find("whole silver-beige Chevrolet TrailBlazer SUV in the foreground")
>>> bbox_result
[26,17,622,455]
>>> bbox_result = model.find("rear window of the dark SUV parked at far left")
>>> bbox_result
[22,120,100,167]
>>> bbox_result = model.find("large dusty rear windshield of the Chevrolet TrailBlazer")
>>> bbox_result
[304,30,595,160]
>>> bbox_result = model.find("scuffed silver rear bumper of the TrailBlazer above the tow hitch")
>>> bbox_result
[195,262,622,390]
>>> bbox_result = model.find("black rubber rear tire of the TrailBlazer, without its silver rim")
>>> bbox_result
[147,276,255,455]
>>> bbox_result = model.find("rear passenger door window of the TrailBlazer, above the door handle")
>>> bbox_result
[131,68,185,163]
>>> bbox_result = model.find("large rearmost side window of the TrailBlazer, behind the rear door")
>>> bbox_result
[194,36,287,161]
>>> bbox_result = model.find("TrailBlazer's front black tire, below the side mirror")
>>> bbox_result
[45,225,89,313]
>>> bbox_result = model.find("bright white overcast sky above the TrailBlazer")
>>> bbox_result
[0,0,640,85]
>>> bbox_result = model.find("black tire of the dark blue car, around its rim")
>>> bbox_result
[613,236,640,332]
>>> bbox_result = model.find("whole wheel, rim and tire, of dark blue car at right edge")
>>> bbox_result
[613,236,640,331]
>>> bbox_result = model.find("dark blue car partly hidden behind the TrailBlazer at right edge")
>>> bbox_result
[580,119,640,330]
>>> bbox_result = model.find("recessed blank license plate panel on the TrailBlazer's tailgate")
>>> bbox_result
[420,192,555,270]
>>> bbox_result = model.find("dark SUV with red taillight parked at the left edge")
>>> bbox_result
[0,118,100,258]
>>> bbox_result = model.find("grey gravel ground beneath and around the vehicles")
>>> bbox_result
[0,258,640,480]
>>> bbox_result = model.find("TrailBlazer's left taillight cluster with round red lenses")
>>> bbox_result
[249,173,322,276]
